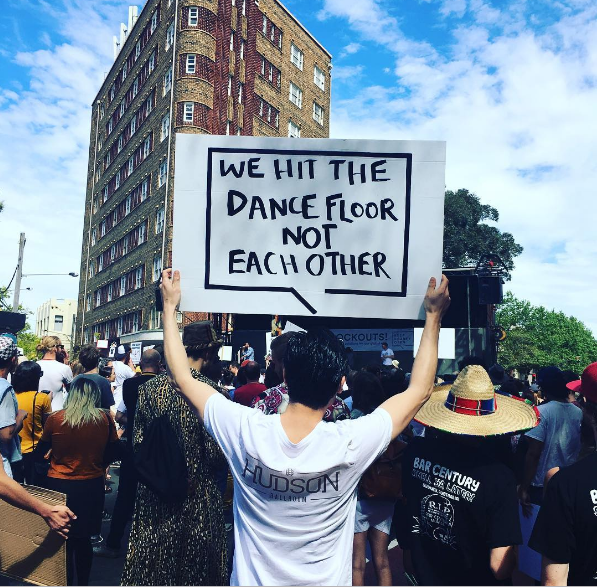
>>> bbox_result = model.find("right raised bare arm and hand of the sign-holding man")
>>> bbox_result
[380,275,450,439]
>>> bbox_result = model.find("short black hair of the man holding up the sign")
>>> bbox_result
[284,329,348,410]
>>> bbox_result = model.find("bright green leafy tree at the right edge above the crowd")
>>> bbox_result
[496,292,597,373]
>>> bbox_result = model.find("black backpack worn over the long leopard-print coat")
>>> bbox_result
[134,398,189,503]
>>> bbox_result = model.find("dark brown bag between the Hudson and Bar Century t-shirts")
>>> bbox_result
[359,439,407,501]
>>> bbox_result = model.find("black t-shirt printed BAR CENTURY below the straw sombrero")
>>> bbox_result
[402,437,522,585]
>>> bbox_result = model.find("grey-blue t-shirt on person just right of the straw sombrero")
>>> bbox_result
[526,401,582,487]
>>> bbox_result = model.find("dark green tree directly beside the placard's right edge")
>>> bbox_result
[443,189,523,271]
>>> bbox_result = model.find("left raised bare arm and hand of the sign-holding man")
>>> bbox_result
[160,269,218,420]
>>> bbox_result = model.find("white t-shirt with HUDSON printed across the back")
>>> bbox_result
[204,393,392,585]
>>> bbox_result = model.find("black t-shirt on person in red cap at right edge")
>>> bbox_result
[529,453,597,585]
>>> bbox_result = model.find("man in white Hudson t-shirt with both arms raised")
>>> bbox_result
[161,270,450,585]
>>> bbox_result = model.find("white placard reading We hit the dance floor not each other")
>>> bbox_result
[173,134,445,319]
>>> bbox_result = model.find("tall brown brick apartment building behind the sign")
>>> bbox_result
[76,0,331,350]
